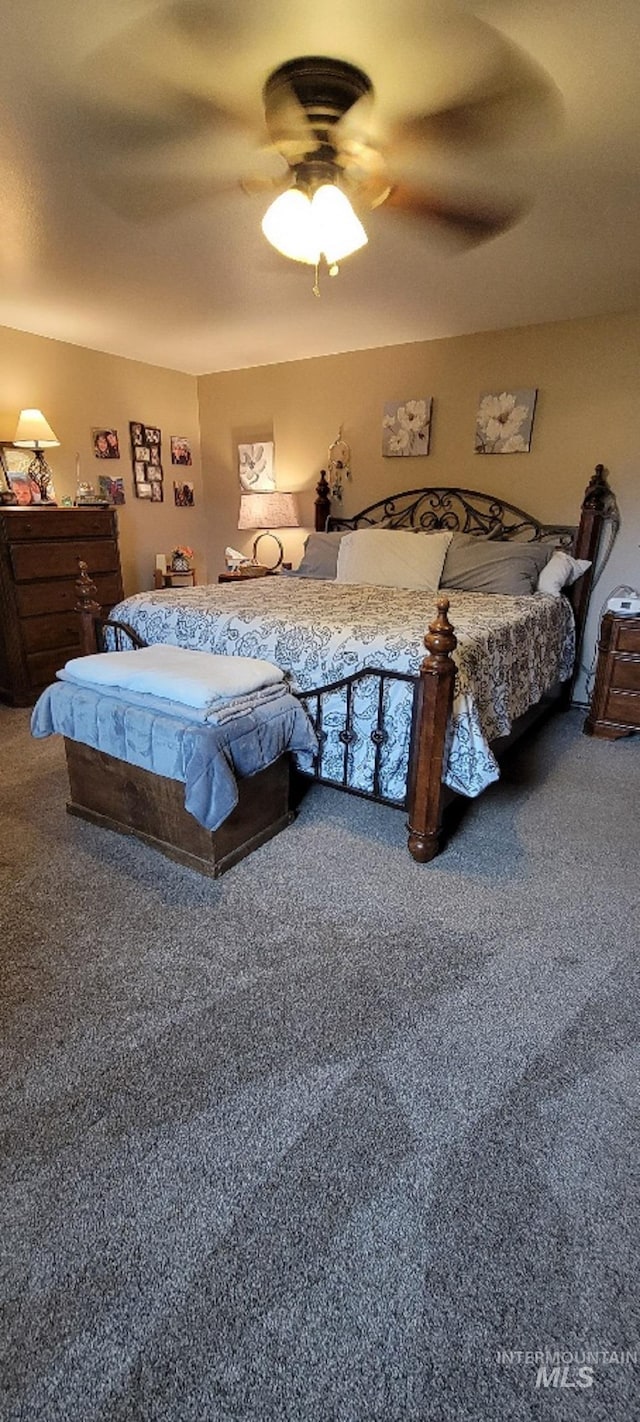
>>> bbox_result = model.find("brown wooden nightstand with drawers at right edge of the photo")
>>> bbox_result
[585,613,640,741]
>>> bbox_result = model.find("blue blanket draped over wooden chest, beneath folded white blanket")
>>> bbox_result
[31,681,317,830]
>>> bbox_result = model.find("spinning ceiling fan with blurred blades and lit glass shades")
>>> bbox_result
[70,0,560,292]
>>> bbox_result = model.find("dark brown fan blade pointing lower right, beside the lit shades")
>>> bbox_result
[384,182,528,246]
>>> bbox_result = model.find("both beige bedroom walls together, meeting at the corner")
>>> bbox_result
[0,316,640,705]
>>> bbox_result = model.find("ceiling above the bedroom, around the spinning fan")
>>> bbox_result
[0,0,640,373]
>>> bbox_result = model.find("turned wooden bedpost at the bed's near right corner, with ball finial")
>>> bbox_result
[408,597,457,865]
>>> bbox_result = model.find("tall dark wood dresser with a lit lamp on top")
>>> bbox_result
[0,508,122,707]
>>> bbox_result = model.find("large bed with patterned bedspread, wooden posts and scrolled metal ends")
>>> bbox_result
[73,465,612,862]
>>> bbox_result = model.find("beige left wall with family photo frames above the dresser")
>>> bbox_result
[0,327,201,593]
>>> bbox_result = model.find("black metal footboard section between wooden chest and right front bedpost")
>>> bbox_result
[294,667,420,809]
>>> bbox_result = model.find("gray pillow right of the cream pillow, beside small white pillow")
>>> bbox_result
[439,533,553,597]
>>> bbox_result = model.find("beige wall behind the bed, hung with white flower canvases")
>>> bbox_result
[198,316,640,702]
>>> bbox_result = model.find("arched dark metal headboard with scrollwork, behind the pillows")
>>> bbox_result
[326,488,576,549]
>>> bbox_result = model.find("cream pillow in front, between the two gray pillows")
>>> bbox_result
[337,529,454,593]
